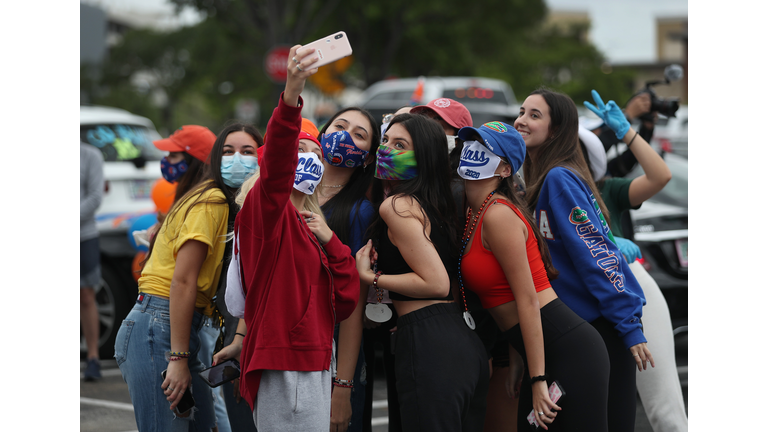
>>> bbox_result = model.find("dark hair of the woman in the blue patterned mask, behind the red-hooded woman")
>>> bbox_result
[317,107,381,246]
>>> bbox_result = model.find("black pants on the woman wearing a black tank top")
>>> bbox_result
[395,303,489,432]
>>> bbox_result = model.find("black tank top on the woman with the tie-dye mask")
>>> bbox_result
[377,202,458,301]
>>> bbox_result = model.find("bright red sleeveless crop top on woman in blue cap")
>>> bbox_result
[461,199,550,309]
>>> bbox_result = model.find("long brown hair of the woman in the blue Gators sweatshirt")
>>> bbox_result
[523,88,611,231]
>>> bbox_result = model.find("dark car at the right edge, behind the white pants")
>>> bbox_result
[627,153,688,349]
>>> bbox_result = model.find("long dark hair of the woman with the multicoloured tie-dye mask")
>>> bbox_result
[369,114,458,250]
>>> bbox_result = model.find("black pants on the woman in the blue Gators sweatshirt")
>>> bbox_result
[590,317,637,432]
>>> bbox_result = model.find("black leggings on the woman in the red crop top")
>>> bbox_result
[504,299,610,432]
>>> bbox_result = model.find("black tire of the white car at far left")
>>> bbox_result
[80,259,135,359]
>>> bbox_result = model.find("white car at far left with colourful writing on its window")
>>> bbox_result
[80,106,165,358]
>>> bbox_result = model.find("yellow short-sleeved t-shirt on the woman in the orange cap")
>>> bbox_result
[139,183,229,316]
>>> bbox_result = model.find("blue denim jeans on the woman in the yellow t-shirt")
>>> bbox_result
[115,294,216,432]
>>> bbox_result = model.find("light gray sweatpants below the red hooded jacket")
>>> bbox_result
[253,370,332,432]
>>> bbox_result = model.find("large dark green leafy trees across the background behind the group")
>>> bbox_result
[81,0,634,132]
